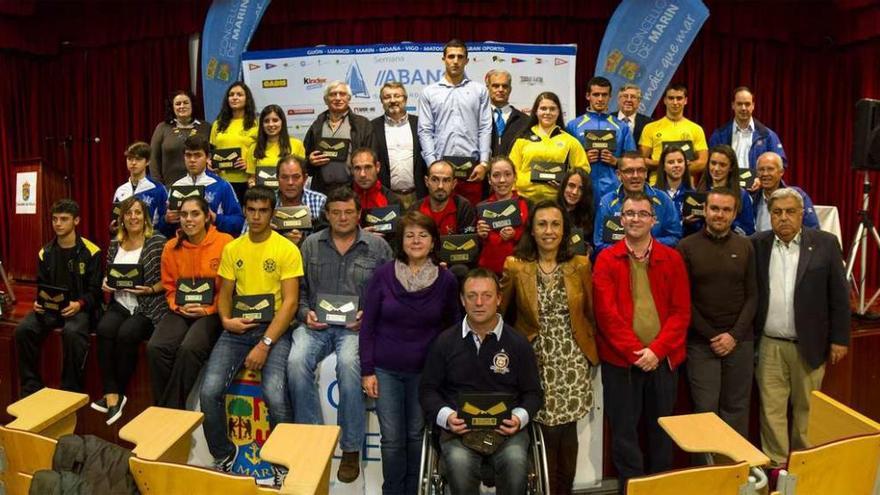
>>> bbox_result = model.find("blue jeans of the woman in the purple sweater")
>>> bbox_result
[376,368,424,495]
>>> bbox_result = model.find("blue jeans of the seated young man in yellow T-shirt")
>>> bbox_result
[199,325,293,459]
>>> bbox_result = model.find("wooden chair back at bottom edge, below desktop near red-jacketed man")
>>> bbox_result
[626,462,749,495]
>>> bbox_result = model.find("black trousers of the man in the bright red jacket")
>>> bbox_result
[602,360,678,493]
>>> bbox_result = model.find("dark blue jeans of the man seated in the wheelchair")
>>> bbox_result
[440,428,529,495]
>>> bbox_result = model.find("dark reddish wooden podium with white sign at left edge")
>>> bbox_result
[5,157,66,281]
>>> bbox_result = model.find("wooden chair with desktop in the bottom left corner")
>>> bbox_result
[0,388,89,495]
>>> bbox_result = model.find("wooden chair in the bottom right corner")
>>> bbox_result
[773,392,880,495]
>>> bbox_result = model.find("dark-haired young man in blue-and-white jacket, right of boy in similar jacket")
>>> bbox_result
[162,135,244,237]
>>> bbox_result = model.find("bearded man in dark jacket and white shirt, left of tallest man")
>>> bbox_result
[370,81,428,208]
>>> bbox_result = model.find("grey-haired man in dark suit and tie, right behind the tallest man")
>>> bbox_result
[486,69,529,156]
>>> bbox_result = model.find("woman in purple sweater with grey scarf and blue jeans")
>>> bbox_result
[360,211,461,494]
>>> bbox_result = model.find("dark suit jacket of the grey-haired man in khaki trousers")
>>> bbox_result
[752,229,850,369]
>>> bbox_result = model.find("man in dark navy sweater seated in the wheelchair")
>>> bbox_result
[419,268,544,495]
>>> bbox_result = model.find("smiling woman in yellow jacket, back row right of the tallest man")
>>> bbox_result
[510,91,590,203]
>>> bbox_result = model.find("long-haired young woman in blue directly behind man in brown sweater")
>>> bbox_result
[697,144,755,236]
